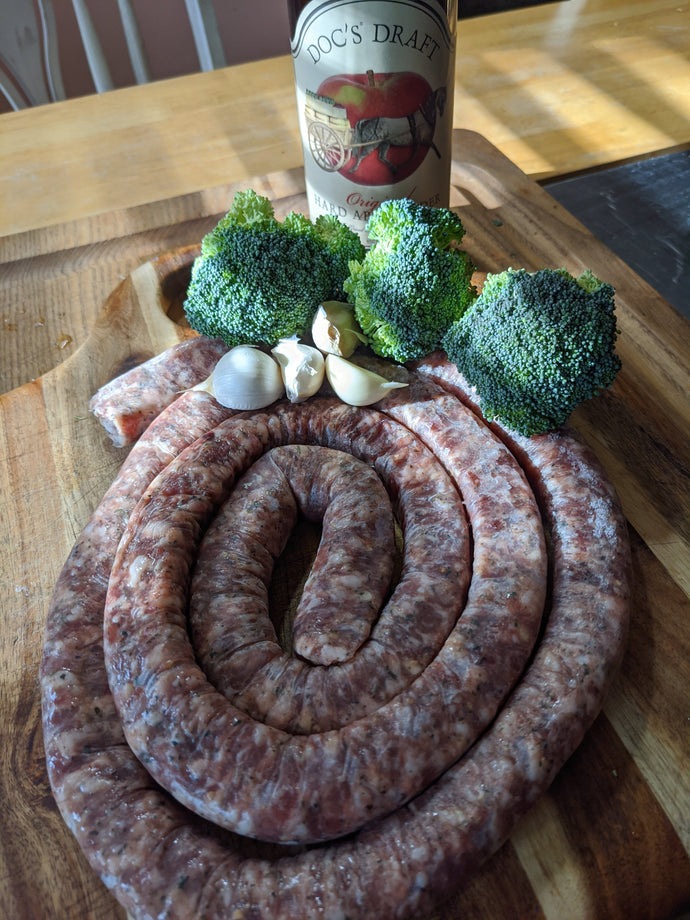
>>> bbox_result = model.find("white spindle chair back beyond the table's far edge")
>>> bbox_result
[0,0,226,109]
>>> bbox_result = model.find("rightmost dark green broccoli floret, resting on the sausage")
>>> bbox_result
[442,269,621,436]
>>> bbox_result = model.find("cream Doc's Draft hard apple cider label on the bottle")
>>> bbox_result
[292,0,455,238]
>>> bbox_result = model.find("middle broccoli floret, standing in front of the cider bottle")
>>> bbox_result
[344,198,477,363]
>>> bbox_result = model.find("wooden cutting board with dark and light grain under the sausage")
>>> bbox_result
[0,131,690,920]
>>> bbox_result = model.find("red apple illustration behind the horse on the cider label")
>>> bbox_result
[318,70,445,185]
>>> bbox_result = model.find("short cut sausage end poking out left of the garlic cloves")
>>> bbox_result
[89,336,228,447]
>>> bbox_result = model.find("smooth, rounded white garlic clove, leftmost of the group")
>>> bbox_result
[194,345,284,409]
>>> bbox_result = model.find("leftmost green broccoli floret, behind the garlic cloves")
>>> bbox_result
[184,189,365,346]
